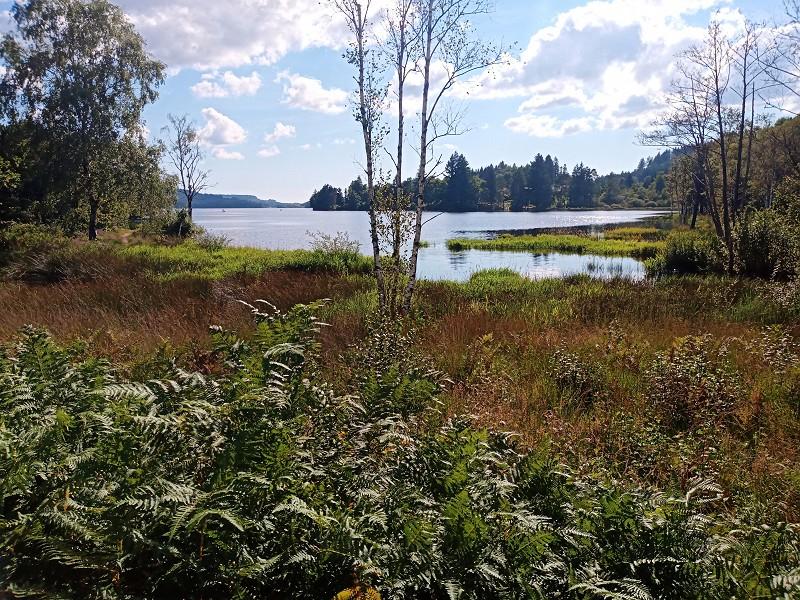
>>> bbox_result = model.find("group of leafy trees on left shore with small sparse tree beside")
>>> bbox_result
[0,0,208,240]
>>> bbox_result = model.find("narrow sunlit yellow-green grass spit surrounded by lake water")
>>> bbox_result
[447,234,663,259]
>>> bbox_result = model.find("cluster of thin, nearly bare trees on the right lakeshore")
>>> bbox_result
[641,12,800,274]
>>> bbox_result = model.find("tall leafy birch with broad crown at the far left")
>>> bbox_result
[0,0,164,240]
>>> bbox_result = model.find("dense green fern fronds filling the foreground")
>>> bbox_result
[0,305,800,600]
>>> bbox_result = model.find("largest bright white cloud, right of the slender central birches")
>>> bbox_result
[454,0,742,137]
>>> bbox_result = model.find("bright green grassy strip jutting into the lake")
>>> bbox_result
[447,227,665,259]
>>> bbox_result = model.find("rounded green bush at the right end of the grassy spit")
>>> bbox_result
[645,230,724,276]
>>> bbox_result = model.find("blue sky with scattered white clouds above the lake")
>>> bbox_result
[0,0,783,202]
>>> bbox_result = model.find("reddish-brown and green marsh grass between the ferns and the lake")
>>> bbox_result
[0,234,800,520]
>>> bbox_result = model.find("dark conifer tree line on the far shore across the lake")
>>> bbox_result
[310,150,673,212]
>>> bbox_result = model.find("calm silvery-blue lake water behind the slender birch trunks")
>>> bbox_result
[194,208,662,281]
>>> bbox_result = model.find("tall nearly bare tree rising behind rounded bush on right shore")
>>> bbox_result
[642,22,763,273]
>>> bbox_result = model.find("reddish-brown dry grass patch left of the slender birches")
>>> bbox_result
[0,271,364,359]
